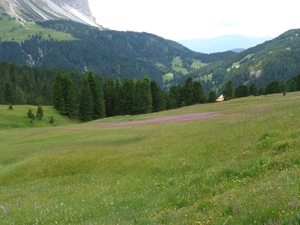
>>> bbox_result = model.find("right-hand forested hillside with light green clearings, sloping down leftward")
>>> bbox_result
[185,29,300,93]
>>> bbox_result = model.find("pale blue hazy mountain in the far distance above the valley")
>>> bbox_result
[178,35,273,53]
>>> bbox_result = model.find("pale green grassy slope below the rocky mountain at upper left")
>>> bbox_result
[0,16,75,43]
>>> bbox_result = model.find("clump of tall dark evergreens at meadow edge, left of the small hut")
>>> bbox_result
[52,71,216,122]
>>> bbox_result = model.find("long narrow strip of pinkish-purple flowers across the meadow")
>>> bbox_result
[106,112,221,127]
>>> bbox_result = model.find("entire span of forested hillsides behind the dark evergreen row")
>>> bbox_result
[0,16,300,96]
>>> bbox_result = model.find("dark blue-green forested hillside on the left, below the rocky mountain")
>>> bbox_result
[0,20,234,86]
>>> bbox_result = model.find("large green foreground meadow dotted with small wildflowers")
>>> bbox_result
[0,93,300,224]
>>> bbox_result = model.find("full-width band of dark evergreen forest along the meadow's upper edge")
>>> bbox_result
[0,61,300,121]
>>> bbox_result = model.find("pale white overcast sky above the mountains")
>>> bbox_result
[89,0,300,41]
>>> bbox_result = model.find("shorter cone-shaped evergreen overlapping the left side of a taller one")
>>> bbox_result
[78,77,94,122]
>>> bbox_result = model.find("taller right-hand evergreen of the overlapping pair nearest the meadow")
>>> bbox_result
[86,71,105,120]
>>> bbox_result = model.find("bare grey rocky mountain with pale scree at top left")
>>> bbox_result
[0,0,101,27]
